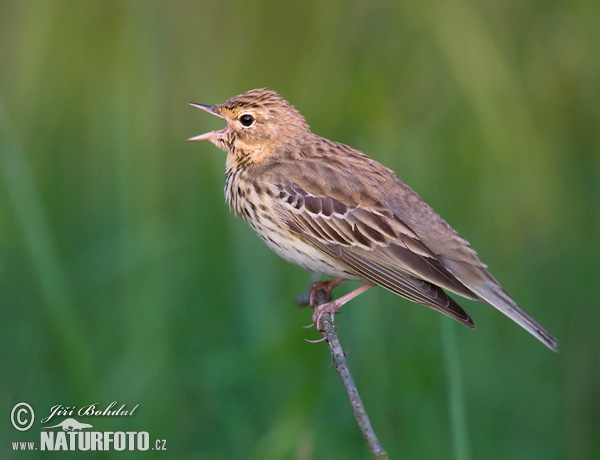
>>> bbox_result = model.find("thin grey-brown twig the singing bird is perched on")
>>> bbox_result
[316,290,388,459]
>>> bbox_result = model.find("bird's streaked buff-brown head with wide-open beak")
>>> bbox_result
[188,89,310,163]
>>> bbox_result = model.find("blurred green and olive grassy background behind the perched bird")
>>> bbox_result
[0,0,600,459]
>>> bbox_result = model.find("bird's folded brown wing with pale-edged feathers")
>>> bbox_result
[277,184,477,327]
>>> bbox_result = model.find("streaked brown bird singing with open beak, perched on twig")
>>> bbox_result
[187,88,557,351]
